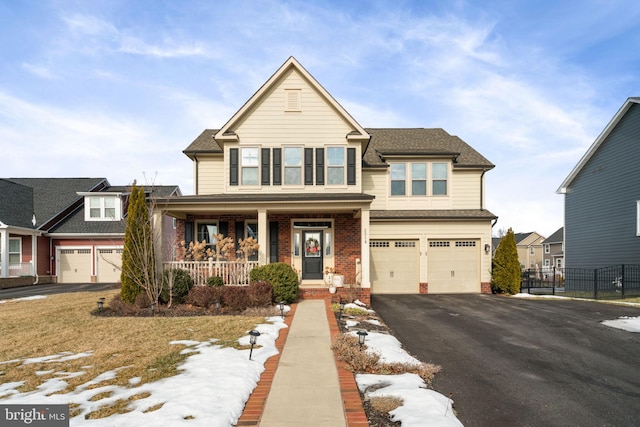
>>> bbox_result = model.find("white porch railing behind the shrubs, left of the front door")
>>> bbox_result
[163,259,258,286]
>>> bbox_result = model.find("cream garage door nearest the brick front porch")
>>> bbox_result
[369,240,420,294]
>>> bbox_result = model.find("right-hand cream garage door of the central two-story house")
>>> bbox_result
[427,240,480,294]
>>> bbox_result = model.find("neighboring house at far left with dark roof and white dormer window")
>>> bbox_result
[0,178,181,287]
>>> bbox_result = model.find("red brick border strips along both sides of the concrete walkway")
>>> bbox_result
[236,299,369,427]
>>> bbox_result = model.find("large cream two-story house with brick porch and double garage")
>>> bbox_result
[158,57,496,298]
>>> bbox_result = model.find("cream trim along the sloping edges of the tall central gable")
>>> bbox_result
[215,56,369,141]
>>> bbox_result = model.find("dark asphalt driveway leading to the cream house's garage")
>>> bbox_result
[372,295,640,427]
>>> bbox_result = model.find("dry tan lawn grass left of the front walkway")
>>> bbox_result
[0,291,264,408]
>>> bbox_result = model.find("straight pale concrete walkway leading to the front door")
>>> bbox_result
[260,300,347,427]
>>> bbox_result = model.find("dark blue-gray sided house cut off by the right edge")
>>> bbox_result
[557,98,640,268]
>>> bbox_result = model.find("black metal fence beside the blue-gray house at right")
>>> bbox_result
[520,264,640,299]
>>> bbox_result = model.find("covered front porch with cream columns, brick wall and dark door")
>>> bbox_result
[155,194,373,297]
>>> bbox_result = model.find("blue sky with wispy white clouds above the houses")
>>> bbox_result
[0,0,640,236]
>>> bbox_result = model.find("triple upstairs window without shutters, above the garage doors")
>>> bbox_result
[390,162,449,196]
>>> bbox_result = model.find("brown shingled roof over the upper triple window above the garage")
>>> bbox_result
[363,128,495,169]
